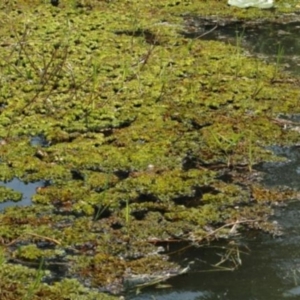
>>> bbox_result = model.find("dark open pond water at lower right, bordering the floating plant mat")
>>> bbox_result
[128,147,300,300]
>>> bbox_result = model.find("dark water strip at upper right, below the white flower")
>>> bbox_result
[184,17,300,74]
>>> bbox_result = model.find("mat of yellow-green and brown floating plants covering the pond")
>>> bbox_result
[0,0,300,299]
